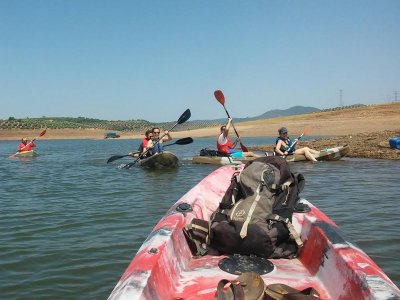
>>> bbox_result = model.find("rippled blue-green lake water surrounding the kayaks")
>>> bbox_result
[0,138,400,299]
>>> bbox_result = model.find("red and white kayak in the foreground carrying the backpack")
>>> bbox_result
[109,165,400,299]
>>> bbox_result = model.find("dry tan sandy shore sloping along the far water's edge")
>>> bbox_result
[0,102,400,159]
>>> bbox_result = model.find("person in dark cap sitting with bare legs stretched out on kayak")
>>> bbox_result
[275,127,319,161]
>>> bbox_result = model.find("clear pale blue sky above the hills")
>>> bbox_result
[0,0,400,122]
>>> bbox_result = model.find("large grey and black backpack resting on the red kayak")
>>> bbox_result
[186,156,304,258]
